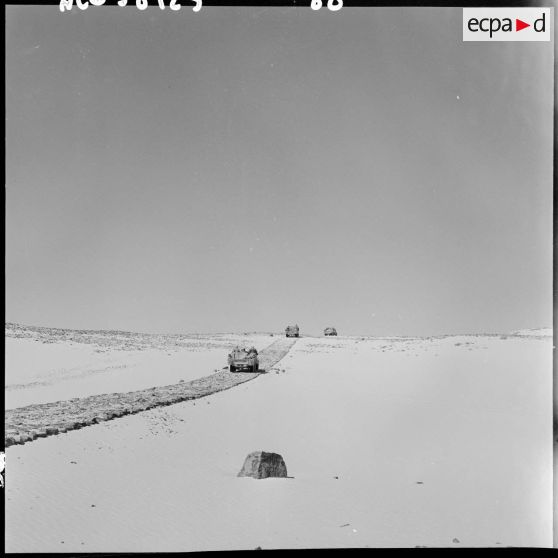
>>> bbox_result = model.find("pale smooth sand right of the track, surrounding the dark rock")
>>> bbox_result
[6,335,552,552]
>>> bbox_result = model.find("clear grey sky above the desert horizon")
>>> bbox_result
[6,5,553,336]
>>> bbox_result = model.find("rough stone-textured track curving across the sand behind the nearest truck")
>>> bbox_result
[5,338,296,447]
